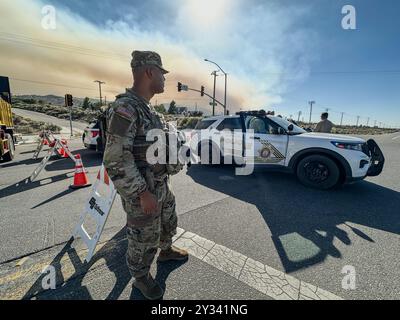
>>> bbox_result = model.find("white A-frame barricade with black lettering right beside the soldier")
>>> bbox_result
[72,165,117,262]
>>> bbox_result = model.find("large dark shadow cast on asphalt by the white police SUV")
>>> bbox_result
[187,165,400,273]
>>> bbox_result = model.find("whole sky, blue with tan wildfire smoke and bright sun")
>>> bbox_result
[0,0,400,127]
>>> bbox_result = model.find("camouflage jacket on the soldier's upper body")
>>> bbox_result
[103,89,167,199]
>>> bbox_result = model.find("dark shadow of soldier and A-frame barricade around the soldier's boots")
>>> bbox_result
[23,227,188,300]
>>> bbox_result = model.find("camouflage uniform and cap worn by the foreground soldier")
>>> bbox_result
[103,51,183,278]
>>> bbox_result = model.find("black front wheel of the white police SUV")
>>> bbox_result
[297,155,340,190]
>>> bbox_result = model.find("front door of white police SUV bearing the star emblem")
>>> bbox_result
[244,115,288,166]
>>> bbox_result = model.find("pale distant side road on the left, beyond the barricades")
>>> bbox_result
[12,108,87,134]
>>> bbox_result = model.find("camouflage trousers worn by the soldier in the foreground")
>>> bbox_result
[122,178,177,278]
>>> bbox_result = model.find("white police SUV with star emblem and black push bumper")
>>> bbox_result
[192,110,385,189]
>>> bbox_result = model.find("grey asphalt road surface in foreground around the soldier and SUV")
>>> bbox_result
[0,129,400,299]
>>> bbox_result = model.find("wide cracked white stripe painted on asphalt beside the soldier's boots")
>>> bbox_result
[173,228,342,300]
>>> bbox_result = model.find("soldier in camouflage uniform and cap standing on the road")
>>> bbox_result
[103,51,188,299]
